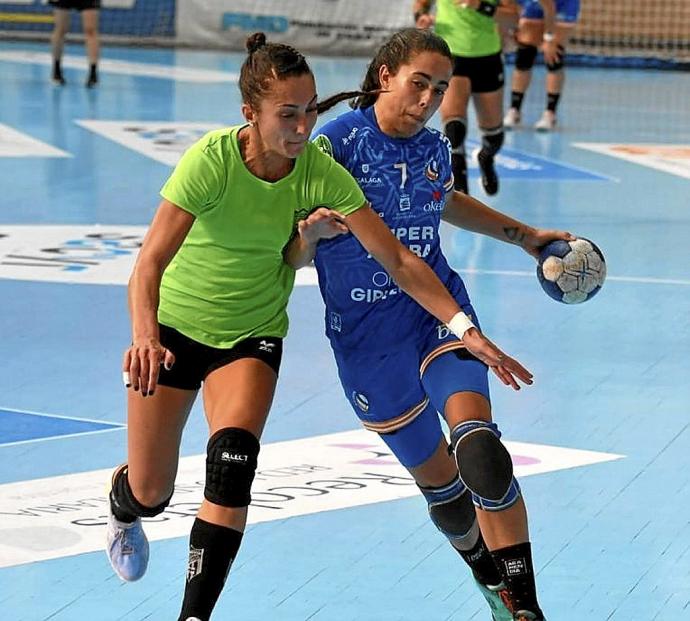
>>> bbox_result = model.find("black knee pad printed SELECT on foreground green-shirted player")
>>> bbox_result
[204,427,259,507]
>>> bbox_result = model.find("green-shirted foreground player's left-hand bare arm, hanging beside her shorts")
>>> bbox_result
[122,200,194,396]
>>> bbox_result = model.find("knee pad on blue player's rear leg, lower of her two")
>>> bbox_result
[420,477,479,550]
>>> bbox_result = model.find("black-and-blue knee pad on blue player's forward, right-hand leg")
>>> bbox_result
[451,420,520,511]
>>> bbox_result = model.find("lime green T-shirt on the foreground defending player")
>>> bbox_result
[158,126,366,348]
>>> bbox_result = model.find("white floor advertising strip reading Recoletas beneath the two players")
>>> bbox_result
[0,428,625,567]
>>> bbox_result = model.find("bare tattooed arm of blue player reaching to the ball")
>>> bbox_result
[443,192,575,257]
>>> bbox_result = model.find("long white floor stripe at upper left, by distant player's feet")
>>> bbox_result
[0,51,239,83]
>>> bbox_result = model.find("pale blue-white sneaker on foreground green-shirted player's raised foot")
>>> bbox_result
[105,509,149,582]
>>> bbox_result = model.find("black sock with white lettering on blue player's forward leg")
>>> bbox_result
[491,541,543,619]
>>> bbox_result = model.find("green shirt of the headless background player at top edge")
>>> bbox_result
[434,0,501,58]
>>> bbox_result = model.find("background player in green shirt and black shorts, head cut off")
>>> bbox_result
[413,0,504,196]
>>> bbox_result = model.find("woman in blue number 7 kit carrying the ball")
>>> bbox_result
[285,29,573,621]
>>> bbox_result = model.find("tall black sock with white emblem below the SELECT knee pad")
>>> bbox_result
[179,518,242,621]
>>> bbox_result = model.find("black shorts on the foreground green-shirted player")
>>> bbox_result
[158,324,283,390]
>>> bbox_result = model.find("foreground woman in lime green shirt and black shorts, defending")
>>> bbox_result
[107,33,532,621]
